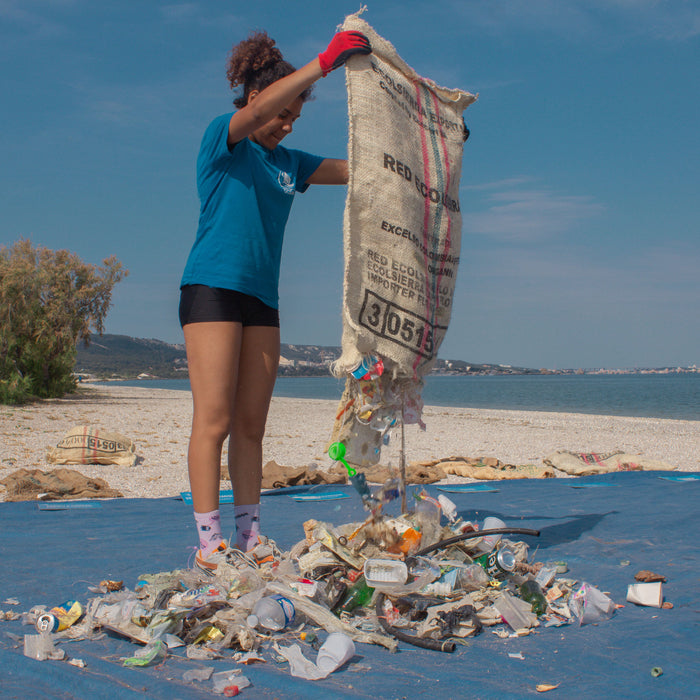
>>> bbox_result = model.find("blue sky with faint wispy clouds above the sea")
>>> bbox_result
[0,0,700,368]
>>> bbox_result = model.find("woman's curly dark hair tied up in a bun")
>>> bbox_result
[226,31,311,109]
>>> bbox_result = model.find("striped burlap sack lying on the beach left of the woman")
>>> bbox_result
[46,425,136,467]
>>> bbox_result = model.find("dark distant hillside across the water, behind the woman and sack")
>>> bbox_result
[75,335,539,379]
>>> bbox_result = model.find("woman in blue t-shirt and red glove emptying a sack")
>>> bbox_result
[180,32,371,573]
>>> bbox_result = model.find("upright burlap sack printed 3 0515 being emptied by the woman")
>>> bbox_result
[335,8,476,378]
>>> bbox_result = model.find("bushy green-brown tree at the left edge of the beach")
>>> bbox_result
[0,239,128,403]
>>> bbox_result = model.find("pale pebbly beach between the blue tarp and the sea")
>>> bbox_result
[0,384,700,500]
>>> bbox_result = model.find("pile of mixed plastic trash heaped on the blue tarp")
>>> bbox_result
[9,484,615,694]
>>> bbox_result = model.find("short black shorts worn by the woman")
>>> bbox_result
[180,284,280,328]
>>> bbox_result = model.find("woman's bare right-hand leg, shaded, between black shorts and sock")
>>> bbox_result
[228,326,280,506]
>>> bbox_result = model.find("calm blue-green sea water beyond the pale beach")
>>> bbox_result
[95,373,700,420]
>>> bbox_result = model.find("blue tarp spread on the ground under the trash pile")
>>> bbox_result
[0,472,700,700]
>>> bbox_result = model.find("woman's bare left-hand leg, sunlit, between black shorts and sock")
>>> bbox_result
[183,322,243,513]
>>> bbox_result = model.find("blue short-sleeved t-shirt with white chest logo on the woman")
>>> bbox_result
[180,114,323,308]
